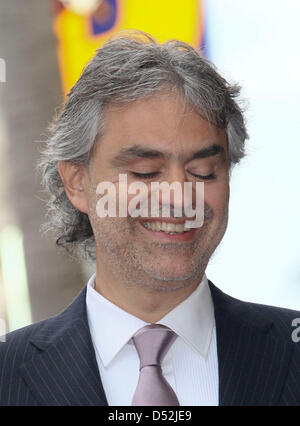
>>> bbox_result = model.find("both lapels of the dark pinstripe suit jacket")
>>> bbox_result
[20,282,293,405]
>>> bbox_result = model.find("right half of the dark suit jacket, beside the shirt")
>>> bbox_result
[209,282,300,406]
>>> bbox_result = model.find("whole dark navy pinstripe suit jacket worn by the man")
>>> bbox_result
[0,282,300,405]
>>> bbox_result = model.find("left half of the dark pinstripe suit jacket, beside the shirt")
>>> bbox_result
[0,289,107,406]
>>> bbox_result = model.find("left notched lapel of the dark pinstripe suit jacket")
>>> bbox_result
[21,291,107,405]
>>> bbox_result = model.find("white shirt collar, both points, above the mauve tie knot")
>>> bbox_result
[86,274,214,367]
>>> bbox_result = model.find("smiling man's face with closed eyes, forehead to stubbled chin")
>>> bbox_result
[83,94,229,289]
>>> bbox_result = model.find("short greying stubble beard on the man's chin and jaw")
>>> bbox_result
[89,195,228,292]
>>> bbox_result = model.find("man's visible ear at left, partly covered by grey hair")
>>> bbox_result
[57,161,88,214]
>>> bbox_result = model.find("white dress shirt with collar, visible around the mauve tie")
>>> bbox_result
[86,274,219,405]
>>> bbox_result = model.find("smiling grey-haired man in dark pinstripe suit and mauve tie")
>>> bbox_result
[0,33,300,406]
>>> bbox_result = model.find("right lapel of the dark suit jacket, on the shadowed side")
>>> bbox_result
[210,283,292,405]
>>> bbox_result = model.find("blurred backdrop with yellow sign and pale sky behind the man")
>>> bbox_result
[0,0,300,335]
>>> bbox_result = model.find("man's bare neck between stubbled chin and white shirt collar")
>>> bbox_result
[95,255,204,323]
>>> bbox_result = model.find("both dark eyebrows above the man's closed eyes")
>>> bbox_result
[110,143,225,167]
